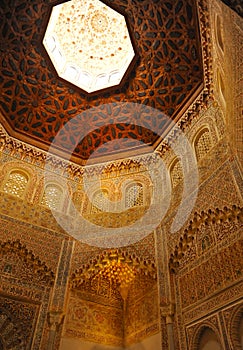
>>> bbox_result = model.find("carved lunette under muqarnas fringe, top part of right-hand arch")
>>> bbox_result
[169,206,243,272]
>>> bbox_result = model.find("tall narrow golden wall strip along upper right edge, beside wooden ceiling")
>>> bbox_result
[209,0,243,171]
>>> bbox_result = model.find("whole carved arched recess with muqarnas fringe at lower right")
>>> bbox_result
[170,202,243,349]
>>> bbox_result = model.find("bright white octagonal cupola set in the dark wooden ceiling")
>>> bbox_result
[43,0,135,93]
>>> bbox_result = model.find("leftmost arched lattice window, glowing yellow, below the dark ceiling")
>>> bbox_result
[3,171,28,197]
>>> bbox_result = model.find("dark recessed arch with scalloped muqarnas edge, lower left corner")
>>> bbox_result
[0,240,54,350]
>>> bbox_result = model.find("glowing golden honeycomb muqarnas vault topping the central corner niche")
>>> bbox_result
[70,250,157,300]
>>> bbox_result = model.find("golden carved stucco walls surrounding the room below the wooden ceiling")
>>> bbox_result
[0,0,243,350]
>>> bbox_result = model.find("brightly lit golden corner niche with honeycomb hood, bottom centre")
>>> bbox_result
[68,249,159,345]
